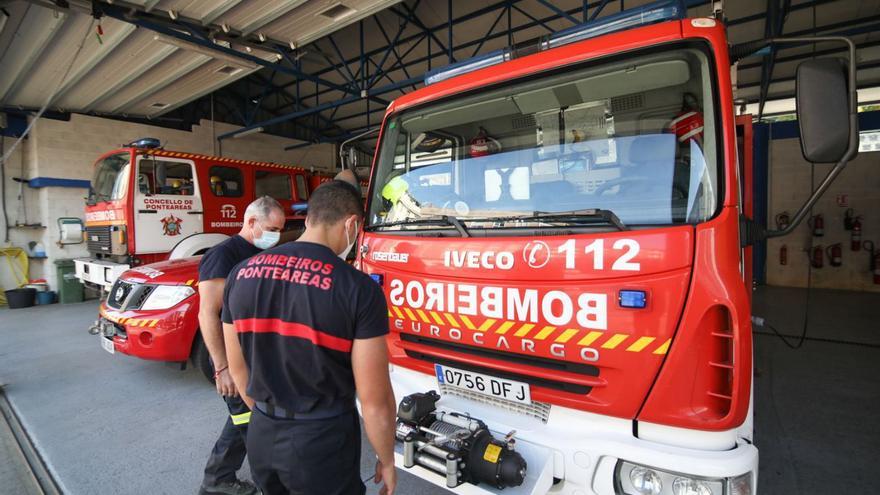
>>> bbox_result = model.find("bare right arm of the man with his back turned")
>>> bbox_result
[351,336,397,495]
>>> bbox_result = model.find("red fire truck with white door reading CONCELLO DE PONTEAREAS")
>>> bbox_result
[75,138,321,290]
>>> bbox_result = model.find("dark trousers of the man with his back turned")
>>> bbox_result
[247,409,366,495]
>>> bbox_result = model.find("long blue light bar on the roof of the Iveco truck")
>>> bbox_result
[425,0,687,86]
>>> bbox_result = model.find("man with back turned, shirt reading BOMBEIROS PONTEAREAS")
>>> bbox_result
[222,180,397,495]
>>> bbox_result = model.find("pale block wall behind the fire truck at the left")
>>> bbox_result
[0,114,336,289]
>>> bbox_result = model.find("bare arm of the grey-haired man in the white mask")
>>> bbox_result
[199,278,235,396]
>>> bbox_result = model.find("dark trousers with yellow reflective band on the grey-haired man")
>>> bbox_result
[203,396,250,486]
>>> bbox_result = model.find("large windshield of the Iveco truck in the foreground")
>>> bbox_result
[368,47,719,230]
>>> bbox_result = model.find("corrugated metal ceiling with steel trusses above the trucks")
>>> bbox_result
[0,0,880,138]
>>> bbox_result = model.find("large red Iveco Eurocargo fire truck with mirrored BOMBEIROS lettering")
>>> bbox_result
[357,1,858,495]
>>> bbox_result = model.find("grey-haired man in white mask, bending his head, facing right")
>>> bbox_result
[199,196,284,495]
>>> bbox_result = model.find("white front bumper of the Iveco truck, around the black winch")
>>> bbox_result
[391,366,758,495]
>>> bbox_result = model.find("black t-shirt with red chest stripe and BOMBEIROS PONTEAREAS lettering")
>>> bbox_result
[222,242,388,414]
